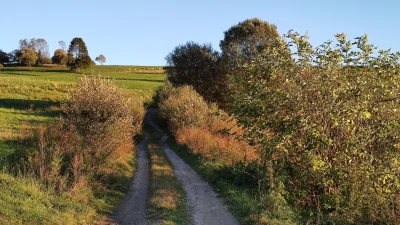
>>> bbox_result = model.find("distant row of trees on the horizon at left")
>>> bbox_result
[0,37,106,71]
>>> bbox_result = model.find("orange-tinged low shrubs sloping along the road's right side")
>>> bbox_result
[157,83,257,165]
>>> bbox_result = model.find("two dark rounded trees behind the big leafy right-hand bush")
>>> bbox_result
[165,18,279,109]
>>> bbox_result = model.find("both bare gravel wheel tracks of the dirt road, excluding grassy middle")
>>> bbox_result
[108,109,238,225]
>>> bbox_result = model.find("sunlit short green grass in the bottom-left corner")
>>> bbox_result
[0,174,98,225]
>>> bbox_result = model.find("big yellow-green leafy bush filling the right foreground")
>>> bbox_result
[232,32,400,224]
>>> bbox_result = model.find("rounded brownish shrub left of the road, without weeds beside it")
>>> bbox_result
[63,76,144,176]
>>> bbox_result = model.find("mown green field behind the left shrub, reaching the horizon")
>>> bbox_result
[0,66,165,157]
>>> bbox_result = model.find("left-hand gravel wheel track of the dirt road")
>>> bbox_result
[109,132,150,225]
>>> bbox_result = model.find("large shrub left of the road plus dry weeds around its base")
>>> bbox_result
[9,76,144,192]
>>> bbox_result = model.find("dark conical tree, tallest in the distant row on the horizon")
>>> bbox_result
[67,37,92,72]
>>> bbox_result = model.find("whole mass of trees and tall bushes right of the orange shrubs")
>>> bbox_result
[166,18,400,224]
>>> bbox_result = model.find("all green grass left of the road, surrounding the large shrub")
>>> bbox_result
[0,66,166,224]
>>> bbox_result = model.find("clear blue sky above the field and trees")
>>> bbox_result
[0,0,400,65]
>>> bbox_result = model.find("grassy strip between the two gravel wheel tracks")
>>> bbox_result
[148,131,188,225]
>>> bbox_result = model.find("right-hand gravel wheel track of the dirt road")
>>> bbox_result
[148,110,239,225]
